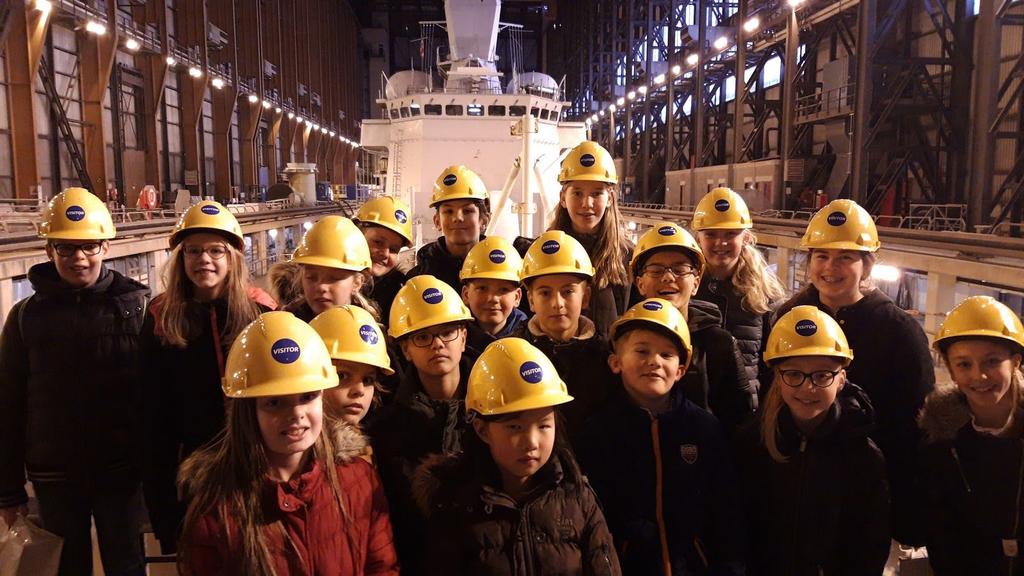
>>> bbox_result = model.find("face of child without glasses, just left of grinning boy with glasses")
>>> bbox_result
[526,274,590,340]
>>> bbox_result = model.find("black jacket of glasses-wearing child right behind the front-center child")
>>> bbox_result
[366,355,473,574]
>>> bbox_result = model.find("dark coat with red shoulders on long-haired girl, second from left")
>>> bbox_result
[140,289,274,553]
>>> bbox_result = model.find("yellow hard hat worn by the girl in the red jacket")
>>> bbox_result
[221,312,338,398]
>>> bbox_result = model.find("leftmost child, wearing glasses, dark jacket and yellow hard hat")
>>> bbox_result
[0,188,150,574]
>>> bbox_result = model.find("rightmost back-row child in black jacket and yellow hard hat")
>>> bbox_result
[777,200,935,546]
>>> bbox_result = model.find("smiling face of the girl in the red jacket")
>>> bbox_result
[256,390,324,461]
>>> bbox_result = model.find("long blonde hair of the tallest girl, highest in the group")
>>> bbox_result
[548,181,630,290]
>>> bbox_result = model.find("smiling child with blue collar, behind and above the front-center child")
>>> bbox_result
[459,236,526,353]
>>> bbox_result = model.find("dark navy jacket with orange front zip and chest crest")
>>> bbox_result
[575,380,743,576]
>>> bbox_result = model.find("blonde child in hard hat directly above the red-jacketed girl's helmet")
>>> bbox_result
[285,215,373,322]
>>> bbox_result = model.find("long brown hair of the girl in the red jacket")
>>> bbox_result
[177,398,364,576]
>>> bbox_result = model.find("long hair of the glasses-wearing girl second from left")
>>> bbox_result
[157,243,260,347]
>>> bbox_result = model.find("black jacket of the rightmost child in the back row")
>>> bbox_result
[777,286,935,546]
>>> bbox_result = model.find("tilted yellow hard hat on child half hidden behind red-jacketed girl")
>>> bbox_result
[309,305,394,375]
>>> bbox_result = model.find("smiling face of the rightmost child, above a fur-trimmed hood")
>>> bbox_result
[945,338,1021,410]
